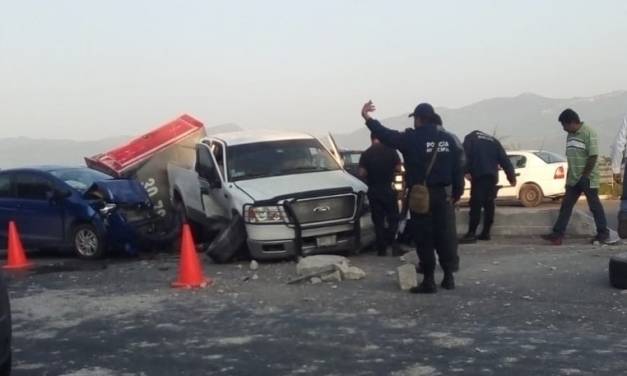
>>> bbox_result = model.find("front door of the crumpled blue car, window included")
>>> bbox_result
[15,172,64,247]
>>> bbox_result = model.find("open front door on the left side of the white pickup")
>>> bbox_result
[195,143,230,217]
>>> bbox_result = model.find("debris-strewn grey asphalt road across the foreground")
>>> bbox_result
[3,239,627,376]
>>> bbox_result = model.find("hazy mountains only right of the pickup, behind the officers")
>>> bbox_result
[335,91,627,155]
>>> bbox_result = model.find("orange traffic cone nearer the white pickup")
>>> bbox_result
[172,223,213,289]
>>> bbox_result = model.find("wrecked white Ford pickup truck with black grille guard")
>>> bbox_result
[168,131,374,261]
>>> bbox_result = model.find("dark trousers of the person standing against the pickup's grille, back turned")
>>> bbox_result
[368,185,400,252]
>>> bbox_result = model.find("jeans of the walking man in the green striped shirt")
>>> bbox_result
[553,186,610,237]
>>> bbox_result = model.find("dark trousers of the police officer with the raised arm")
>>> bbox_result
[411,187,459,276]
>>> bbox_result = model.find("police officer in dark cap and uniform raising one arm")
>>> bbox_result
[361,101,464,293]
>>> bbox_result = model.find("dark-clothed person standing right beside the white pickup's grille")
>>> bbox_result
[359,134,401,256]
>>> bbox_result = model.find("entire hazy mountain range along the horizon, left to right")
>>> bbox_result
[0,91,627,169]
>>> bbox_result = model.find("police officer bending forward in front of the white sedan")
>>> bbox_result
[460,131,516,243]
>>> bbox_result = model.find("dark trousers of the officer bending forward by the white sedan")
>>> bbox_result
[468,175,498,234]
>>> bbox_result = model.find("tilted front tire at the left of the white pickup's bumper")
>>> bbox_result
[206,215,246,264]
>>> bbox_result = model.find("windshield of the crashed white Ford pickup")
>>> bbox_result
[227,139,340,181]
